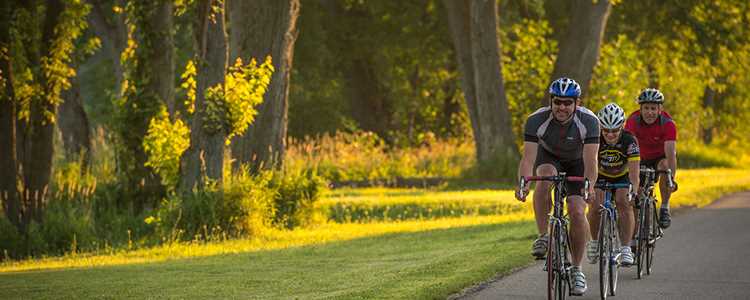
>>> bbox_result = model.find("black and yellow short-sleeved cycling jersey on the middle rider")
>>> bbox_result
[599,130,641,178]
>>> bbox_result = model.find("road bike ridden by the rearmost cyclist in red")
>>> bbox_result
[635,167,674,279]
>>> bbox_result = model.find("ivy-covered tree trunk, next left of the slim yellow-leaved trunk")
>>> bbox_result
[113,0,174,212]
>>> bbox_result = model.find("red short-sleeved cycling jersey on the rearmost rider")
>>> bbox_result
[625,110,677,160]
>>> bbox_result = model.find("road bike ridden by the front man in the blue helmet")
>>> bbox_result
[519,173,589,300]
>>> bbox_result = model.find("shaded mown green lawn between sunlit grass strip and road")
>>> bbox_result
[0,221,535,299]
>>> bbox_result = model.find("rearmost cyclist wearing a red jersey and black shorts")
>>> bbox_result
[625,88,677,228]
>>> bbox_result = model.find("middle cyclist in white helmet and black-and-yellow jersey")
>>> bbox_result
[586,103,641,266]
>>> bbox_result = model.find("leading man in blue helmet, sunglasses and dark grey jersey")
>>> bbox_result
[516,78,599,295]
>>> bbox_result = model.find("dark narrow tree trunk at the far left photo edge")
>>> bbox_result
[0,1,23,231]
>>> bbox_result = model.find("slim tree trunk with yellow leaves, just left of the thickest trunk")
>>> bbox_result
[180,0,227,193]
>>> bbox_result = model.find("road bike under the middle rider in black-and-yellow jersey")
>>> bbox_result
[595,181,633,299]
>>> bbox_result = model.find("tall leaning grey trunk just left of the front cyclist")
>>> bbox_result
[444,0,518,179]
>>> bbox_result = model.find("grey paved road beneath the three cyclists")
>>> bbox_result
[461,192,750,300]
